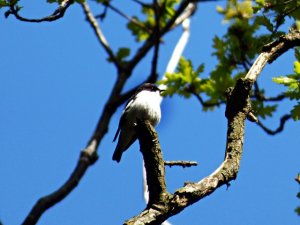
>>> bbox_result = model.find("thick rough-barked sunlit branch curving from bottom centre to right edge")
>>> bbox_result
[124,28,300,225]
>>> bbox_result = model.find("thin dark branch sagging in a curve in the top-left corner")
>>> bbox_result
[5,0,74,23]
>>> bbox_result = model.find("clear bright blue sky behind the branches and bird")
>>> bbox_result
[0,0,300,225]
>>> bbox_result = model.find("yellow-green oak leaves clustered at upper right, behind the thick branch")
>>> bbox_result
[161,0,300,120]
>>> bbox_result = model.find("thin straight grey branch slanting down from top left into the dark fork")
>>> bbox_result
[80,2,121,69]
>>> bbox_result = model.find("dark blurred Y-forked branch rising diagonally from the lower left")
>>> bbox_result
[19,1,195,225]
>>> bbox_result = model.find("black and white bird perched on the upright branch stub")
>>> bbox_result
[112,83,163,162]
